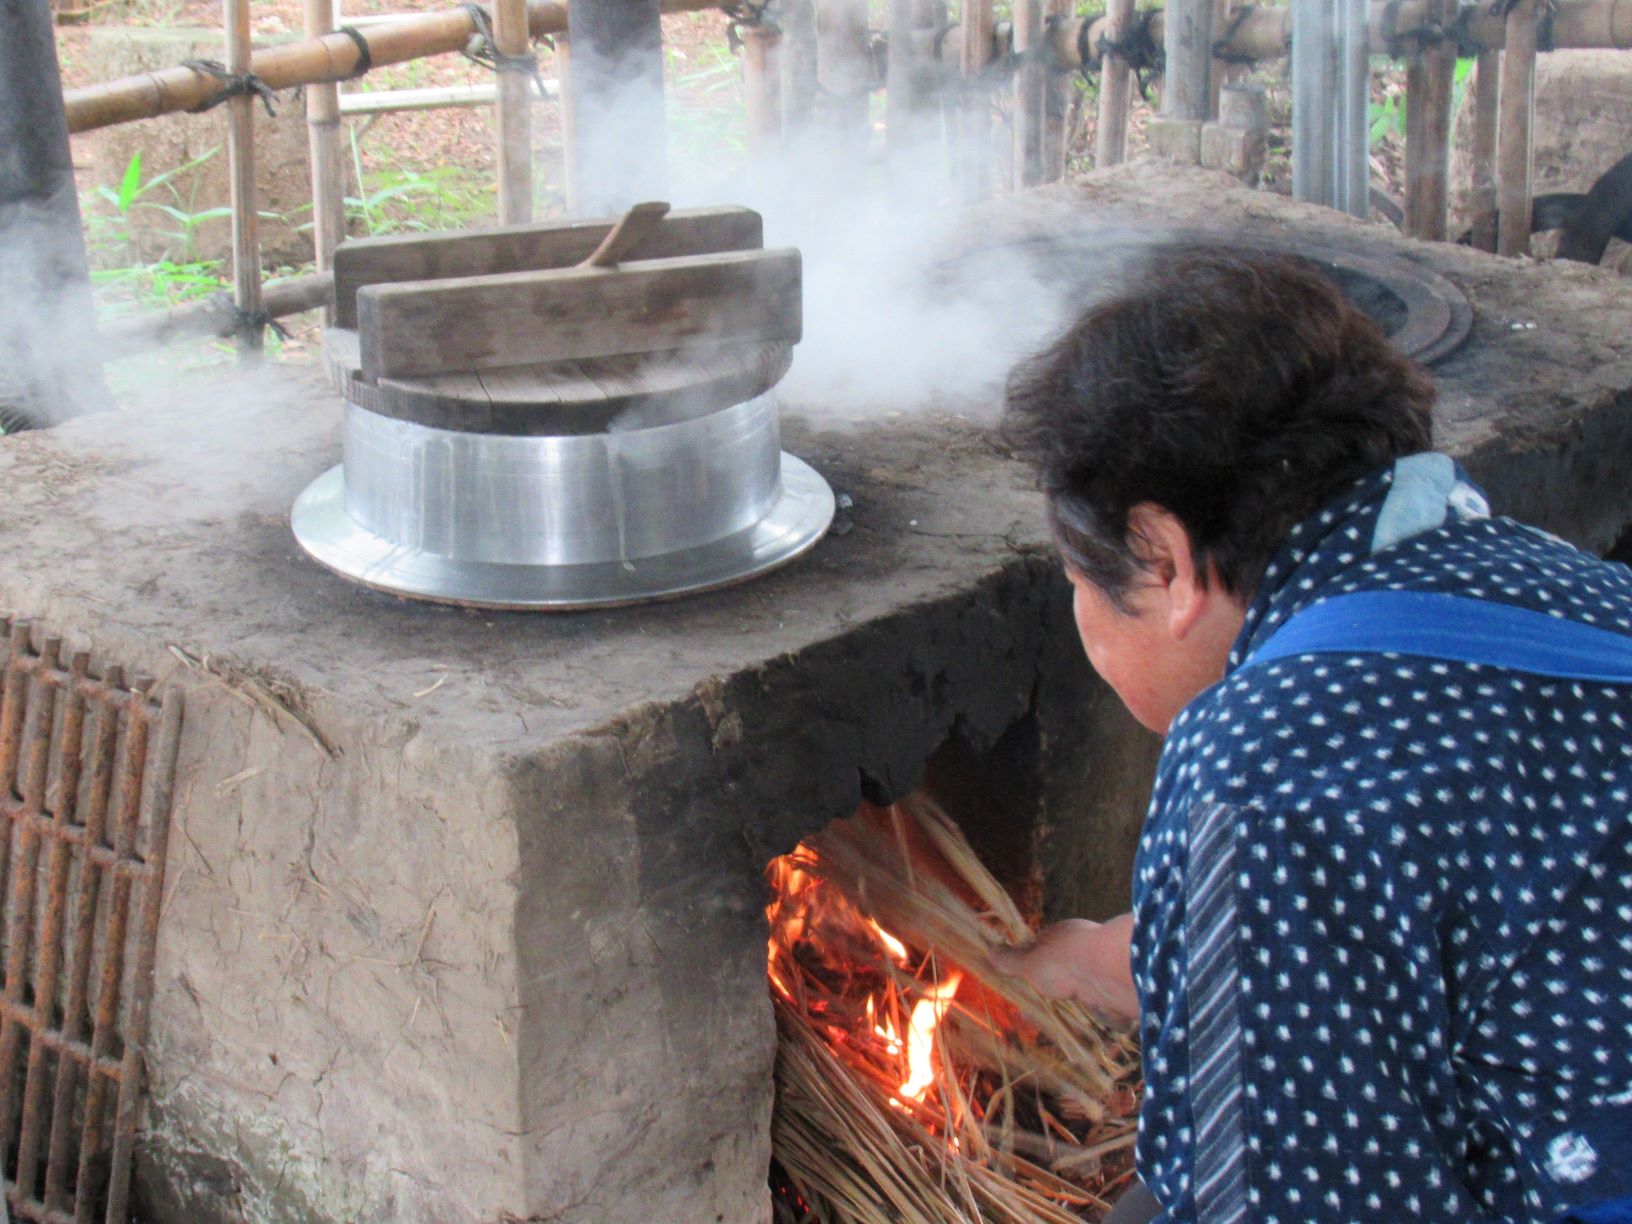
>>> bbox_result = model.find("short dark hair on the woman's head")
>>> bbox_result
[1004,246,1435,604]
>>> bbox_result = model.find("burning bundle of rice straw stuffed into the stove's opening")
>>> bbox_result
[767,798,1139,1224]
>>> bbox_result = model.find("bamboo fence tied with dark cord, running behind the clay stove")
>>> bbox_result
[64,0,1632,359]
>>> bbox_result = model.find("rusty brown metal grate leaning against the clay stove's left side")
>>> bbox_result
[0,617,181,1224]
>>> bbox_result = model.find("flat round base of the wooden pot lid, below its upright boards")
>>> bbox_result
[323,328,793,436]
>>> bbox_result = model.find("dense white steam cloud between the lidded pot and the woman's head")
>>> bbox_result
[674,129,1084,413]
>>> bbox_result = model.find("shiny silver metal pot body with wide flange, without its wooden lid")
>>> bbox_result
[292,393,834,609]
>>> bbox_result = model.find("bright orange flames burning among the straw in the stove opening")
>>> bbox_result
[765,844,963,1108]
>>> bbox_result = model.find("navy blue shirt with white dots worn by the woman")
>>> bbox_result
[1133,455,1632,1224]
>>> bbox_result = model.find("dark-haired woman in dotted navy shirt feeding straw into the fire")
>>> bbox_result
[999,250,1632,1224]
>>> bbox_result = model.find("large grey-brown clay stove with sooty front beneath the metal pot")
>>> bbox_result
[0,165,1632,1224]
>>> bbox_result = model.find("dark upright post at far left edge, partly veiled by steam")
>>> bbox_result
[0,0,111,432]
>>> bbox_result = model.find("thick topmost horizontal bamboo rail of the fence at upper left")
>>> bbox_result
[64,0,714,132]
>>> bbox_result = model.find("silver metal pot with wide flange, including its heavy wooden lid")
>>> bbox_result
[292,204,834,609]
